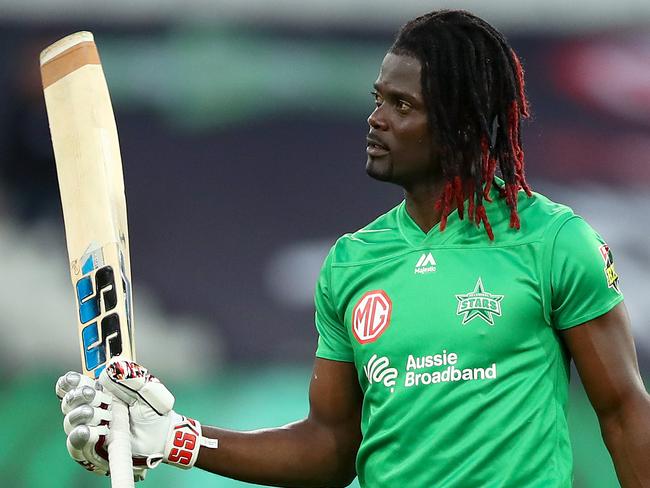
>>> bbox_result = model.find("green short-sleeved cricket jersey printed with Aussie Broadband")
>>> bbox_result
[315,183,623,488]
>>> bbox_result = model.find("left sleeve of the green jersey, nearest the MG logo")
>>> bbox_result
[314,249,354,362]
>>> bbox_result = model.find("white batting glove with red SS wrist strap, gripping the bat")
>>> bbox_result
[56,358,217,481]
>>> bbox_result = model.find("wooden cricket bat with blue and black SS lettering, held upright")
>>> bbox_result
[40,32,135,488]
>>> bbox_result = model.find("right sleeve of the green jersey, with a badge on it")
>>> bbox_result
[551,216,623,329]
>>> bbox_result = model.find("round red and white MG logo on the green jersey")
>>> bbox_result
[352,290,393,344]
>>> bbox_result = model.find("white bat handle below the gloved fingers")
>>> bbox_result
[108,398,135,488]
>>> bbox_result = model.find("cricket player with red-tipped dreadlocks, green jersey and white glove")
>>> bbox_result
[57,11,650,488]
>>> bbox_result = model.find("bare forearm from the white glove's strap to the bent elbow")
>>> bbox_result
[196,420,356,487]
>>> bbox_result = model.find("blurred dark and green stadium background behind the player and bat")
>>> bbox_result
[0,0,650,488]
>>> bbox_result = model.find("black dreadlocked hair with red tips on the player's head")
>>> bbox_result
[390,10,531,240]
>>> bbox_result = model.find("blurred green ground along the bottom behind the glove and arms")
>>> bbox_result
[0,365,618,488]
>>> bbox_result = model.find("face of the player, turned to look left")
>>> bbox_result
[366,53,440,187]
